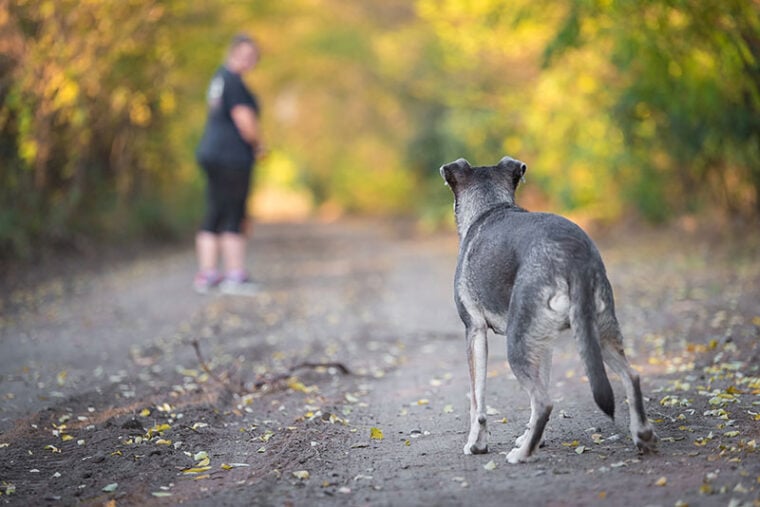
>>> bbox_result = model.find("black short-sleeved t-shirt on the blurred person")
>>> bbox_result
[196,67,259,170]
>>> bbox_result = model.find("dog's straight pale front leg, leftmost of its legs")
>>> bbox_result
[464,327,488,454]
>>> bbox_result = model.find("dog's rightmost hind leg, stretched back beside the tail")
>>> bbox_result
[599,317,657,453]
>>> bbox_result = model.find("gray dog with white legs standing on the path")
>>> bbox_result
[441,157,657,463]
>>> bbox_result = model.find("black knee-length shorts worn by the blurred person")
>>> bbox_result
[201,165,251,234]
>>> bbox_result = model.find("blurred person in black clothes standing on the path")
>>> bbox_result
[193,35,261,294]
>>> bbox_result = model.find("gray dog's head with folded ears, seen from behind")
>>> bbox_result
[440,157,527,232]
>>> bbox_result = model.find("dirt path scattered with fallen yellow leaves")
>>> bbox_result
[0,223,760,506]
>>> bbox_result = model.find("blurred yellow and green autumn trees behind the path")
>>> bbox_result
[0,0,760,258]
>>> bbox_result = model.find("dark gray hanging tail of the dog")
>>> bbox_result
[570,273,615,419]
